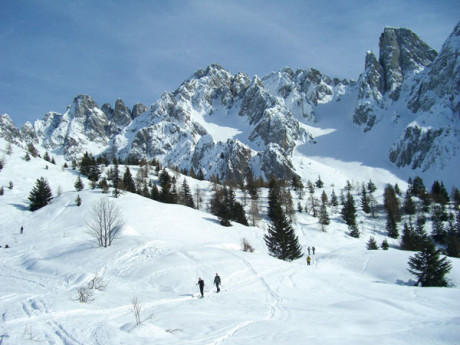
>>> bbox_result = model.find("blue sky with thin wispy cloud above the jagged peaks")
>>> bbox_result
[0,0,460,126]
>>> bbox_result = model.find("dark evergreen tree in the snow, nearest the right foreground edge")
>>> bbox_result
[408,242,452,287]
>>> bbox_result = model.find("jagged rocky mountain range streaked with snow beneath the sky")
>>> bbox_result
[0,23,460,185]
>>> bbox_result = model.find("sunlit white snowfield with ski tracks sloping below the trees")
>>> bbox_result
[0,139,460,345]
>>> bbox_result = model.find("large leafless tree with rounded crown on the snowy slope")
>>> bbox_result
[86,198,125,247]
